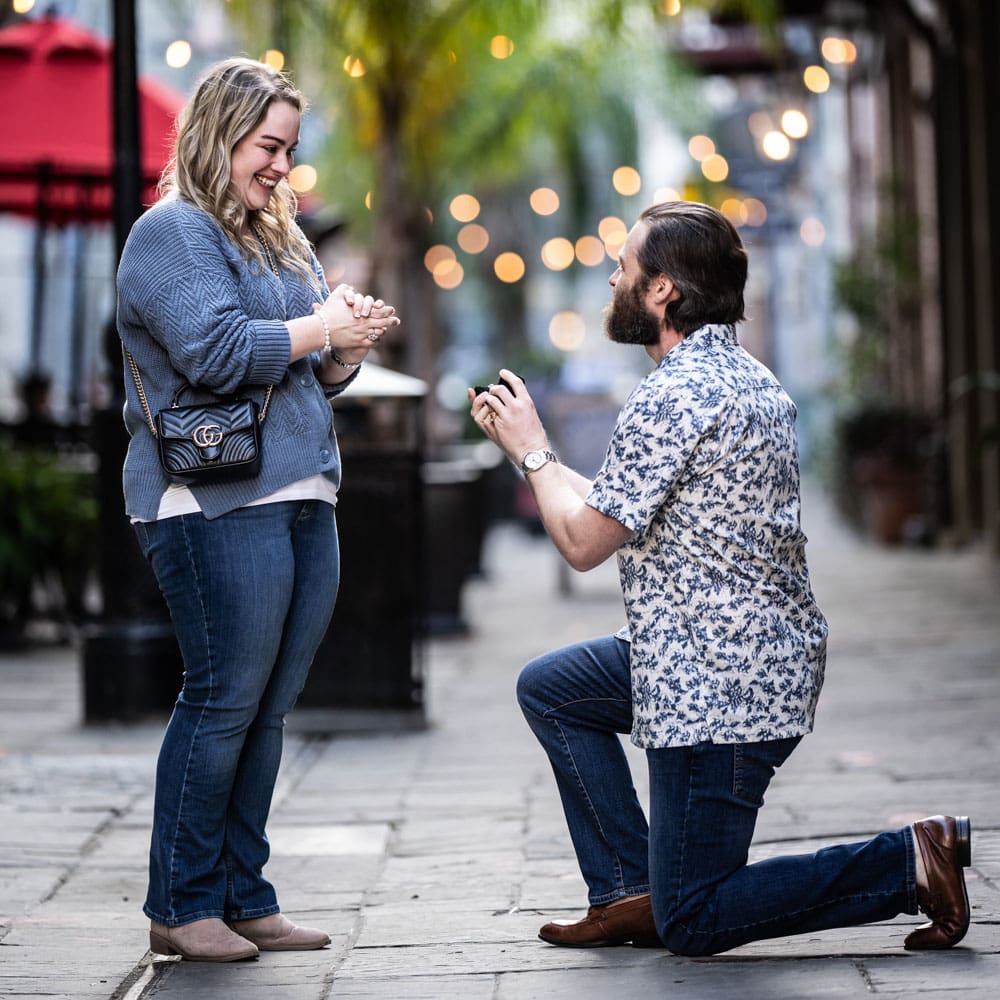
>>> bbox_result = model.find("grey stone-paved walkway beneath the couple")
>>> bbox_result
[0,498,1000,1000]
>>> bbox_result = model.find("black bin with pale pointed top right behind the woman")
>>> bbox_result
[289,362,426,731]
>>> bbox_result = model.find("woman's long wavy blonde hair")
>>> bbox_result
[159,57,318,288]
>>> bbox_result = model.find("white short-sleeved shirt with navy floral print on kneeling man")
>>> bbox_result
[587,326,827,748]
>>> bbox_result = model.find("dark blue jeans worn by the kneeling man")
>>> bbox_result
[518,636,917,955]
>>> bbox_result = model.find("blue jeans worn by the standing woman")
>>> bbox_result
[135,500,340,927]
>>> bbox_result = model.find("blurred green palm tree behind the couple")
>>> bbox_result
[227,0,770,434]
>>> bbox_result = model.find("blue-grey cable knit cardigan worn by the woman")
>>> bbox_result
[118,197,353,521]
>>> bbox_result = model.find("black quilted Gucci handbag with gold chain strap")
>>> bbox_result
[125,351,274,486]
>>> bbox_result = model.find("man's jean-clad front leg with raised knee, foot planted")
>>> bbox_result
[517,636,649,906]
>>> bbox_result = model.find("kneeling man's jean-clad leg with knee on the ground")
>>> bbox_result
[647,739,916,955]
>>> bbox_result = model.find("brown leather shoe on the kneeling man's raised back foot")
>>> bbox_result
[903,816,972,951]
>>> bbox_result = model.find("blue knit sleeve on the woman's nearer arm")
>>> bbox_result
[118,202,290,394]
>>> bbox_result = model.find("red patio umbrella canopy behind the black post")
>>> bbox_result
[0,15,183,224]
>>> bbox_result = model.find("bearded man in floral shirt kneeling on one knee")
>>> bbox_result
[469,202,971,955]
